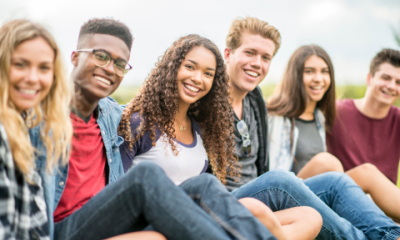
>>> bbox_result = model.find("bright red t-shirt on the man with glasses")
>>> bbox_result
[54,113,107,222]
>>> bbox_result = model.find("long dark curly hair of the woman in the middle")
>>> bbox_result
[118,34,240,183]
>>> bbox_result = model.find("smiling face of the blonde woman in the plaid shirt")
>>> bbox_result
[9,37,55,112]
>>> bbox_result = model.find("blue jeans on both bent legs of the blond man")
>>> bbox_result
[232,170,400,240]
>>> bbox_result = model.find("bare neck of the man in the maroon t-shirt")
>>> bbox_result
[354,95,390,119]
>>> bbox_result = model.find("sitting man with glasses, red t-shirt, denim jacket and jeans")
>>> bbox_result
[31,19,282,240]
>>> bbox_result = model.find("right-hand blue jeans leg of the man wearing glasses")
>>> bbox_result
[180,174,276,240]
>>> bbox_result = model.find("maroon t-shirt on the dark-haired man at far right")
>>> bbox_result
[326,100,400,183]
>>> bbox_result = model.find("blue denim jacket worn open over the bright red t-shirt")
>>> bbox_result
[29,97,124,239]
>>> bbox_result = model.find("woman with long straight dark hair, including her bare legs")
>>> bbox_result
[267,45,400,220]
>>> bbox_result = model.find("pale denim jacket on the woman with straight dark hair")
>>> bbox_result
[268,108,326,171]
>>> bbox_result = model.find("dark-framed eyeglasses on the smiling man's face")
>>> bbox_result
[76,49,132,77]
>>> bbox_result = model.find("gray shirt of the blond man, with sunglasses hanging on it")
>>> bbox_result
[226,96,259,191]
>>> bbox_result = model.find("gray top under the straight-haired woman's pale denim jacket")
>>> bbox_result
[292,119,324,174]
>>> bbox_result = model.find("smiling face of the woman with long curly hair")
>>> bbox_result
[177,46,217,105]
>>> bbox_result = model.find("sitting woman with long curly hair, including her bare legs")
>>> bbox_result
[119,35,322,239]
